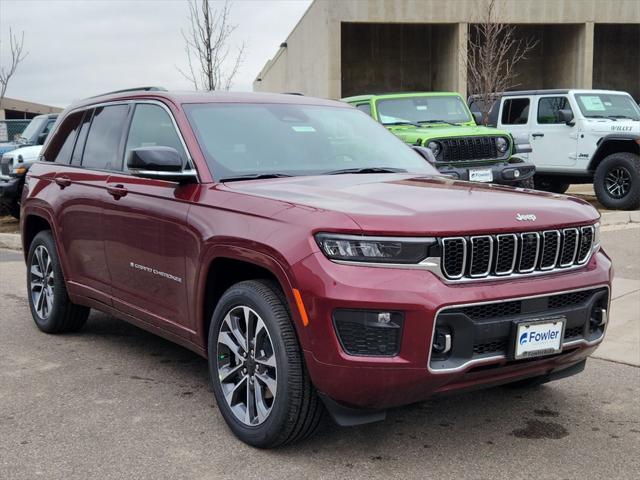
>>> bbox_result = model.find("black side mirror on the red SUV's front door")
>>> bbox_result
[127,147,196,183]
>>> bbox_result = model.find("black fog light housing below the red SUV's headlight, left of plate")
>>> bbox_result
[333,309,404,357]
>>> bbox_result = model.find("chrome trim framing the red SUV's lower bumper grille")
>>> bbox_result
[427,283,611,375]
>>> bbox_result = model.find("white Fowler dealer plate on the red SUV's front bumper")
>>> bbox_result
[513,317,566,360]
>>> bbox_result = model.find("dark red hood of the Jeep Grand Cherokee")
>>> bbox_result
[225,174,599,235]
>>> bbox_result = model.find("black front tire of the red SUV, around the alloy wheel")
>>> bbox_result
[208,280,324,448]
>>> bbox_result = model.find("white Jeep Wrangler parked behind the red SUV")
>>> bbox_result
[470,90,640,210]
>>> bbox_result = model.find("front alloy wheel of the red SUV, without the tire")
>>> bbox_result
[216,305,278,426]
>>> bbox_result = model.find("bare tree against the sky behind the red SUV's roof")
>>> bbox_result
[176,0,245,90]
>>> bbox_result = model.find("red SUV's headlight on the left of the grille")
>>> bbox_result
[316,233,437,264]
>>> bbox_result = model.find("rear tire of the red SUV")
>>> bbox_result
[27,230,90,333]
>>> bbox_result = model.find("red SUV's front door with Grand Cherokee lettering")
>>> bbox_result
[104,102,196,338]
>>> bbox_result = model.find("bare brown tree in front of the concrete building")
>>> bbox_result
[462,0,538,125]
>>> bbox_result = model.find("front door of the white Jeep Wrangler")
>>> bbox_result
[530,95,578,171]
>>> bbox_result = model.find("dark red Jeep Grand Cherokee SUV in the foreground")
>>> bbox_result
[21,88,611,447]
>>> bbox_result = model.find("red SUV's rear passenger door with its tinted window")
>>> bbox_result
[49,104,129,304]
